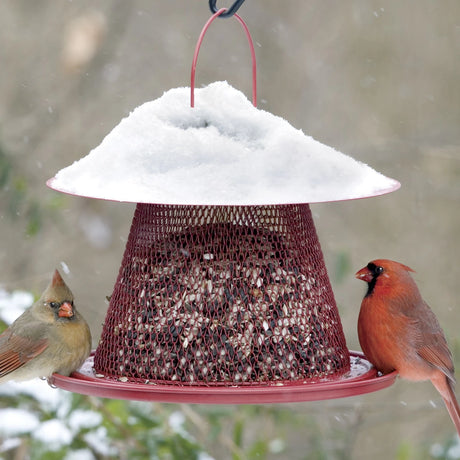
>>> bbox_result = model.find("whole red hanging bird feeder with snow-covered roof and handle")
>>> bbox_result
[48,10,399,403]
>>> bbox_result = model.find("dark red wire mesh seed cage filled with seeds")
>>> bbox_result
[94,204,350,386]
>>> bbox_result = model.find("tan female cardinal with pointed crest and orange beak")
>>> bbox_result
[0,270,91,383]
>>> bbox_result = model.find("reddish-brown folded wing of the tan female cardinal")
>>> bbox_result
[0,329,48,378]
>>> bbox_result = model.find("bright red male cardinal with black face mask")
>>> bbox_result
[356,259,460,435]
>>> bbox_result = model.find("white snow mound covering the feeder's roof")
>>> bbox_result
[48,82,399,205]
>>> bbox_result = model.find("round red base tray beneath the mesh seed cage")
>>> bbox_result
[50,351,397,404]
